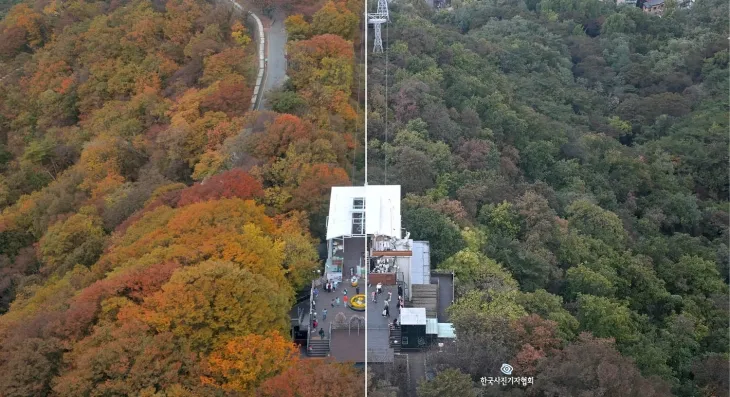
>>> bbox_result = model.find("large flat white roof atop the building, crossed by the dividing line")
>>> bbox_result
[327,185,401,240]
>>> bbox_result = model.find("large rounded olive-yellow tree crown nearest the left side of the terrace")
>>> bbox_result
[144,261,290,351]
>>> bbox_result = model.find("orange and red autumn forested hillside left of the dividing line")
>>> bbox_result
[0,0,364,397]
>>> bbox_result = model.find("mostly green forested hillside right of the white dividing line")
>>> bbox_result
[368,0,729,396]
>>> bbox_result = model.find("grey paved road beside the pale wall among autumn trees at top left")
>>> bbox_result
[260,11,287,109]
